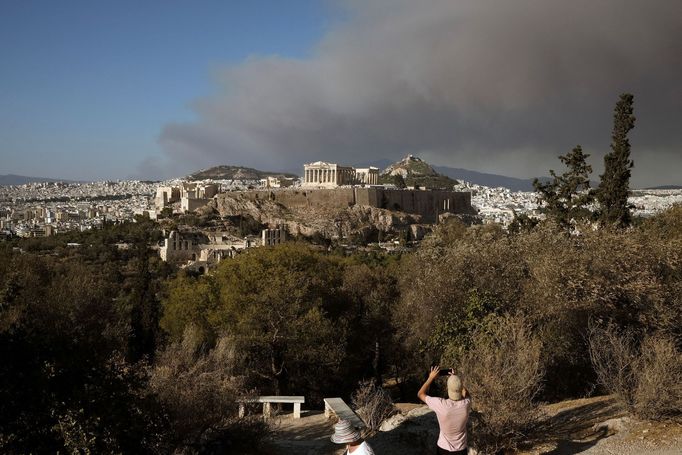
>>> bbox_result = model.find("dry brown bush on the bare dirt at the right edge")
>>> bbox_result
[589,325,682,420]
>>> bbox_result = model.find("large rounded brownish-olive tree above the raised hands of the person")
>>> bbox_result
[395,225,527,360]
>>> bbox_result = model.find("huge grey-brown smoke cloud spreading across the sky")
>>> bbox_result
[160,0,682,185]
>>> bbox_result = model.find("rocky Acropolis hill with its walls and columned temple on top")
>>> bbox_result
[194,161,476,239]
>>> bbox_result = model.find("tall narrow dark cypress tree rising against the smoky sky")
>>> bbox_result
[597,93,635,227]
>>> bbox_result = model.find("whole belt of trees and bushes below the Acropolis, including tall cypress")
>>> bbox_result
[0,97,682,454]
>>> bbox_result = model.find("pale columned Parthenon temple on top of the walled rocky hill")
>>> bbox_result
[303,161,379,188]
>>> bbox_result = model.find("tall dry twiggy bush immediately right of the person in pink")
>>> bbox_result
[454,316,543,453]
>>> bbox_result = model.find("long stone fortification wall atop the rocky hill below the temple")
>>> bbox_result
[236,188,474,223]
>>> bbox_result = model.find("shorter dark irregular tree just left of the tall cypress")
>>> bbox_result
[533,145,594,227]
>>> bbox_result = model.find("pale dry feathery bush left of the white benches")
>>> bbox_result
[150,326,268,453]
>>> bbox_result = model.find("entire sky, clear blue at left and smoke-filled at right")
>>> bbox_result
[0,0,682,187]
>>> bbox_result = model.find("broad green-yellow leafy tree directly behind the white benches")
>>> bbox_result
[213,244,347,395]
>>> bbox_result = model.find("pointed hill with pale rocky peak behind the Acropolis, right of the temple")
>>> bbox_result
[379,155,458,189]
